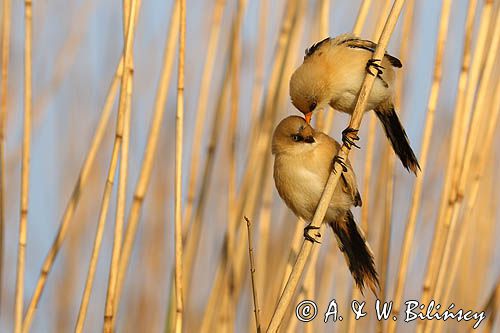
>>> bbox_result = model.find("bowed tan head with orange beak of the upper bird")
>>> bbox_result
[290,62,330,123]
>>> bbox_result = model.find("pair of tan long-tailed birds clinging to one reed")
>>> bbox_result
[272,34,420,294]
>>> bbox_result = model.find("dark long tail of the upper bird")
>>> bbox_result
[374,103,420,175]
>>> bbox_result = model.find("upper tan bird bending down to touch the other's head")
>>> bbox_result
[289,34,420,175]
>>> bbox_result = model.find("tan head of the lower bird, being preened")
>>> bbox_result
[272,116,316,154]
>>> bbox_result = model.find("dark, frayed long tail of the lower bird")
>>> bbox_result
[329,210,380,296]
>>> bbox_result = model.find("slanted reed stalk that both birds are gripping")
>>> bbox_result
[267,0,404,332]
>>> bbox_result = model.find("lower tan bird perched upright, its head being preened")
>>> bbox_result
[272,116,380,295]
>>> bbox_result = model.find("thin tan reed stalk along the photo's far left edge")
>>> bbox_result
[0,0,11,308]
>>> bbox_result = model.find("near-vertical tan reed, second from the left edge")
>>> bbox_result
[14,0,33,333]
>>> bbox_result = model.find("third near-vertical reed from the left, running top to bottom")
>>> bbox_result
[103,0,140,332]
